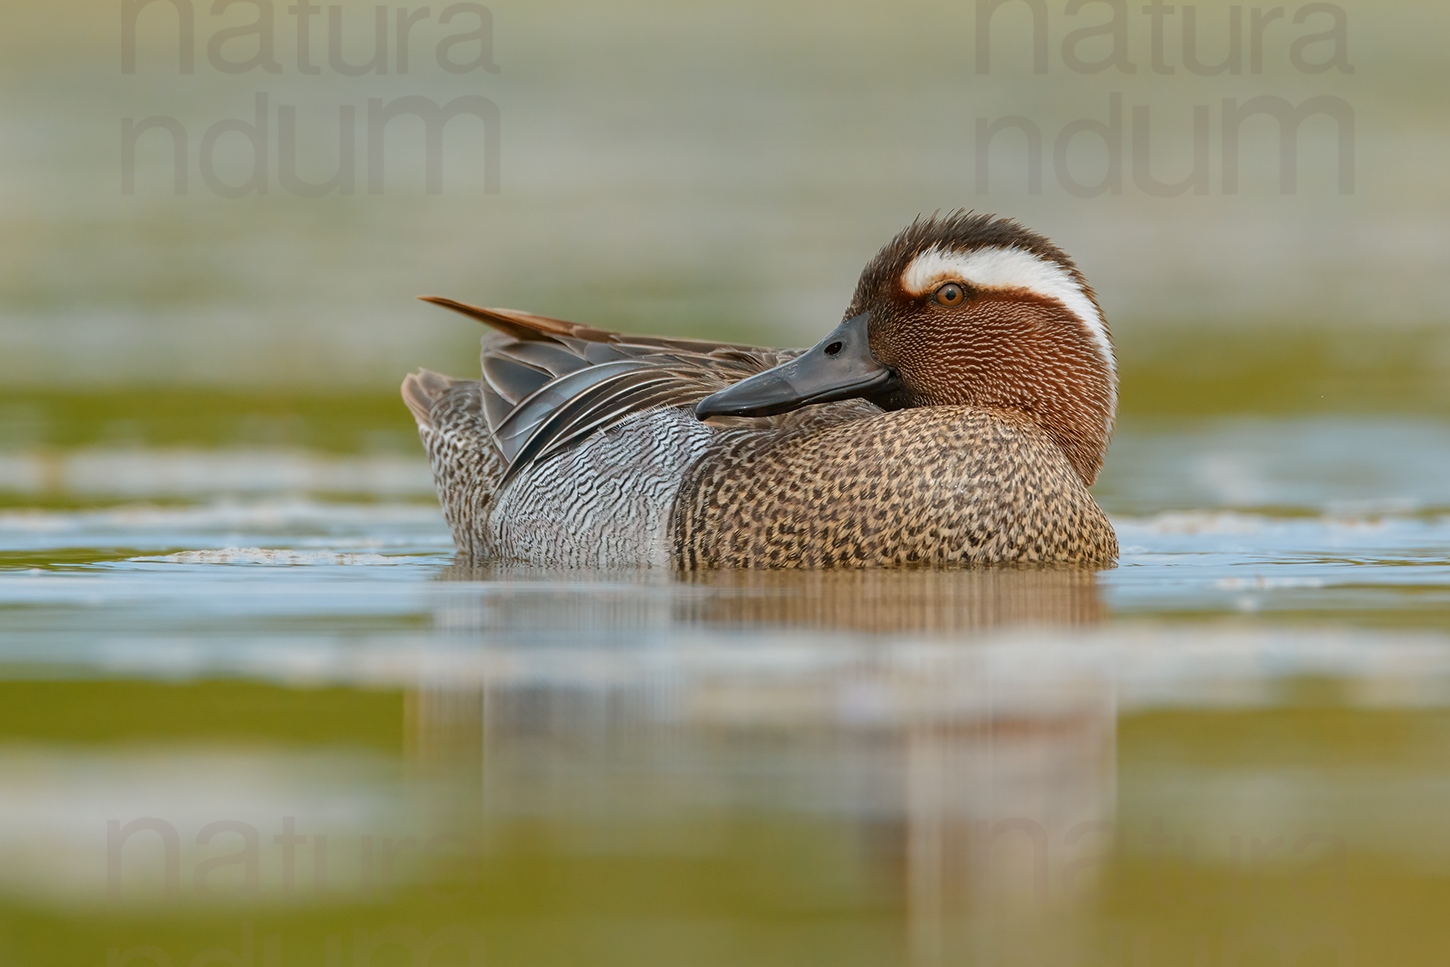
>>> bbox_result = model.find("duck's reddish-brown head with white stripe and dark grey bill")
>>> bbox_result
[695,213,1118,484]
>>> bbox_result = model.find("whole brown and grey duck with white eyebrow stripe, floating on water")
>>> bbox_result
[402,210,1118,571]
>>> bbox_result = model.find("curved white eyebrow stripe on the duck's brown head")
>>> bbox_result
[902,246,1118,388]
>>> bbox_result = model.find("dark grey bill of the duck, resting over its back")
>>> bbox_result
[695,312,896,419]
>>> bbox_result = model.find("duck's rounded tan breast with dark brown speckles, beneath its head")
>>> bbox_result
[674,406,1118,568]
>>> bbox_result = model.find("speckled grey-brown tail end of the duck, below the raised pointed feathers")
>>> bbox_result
[402,370,506,564]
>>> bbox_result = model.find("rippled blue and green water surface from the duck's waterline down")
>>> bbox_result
[0,418,1450,967]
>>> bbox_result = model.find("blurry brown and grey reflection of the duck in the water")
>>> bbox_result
[407,568,1117,964]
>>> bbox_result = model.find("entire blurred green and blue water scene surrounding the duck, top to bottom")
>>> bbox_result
[0,0,1450,967]
